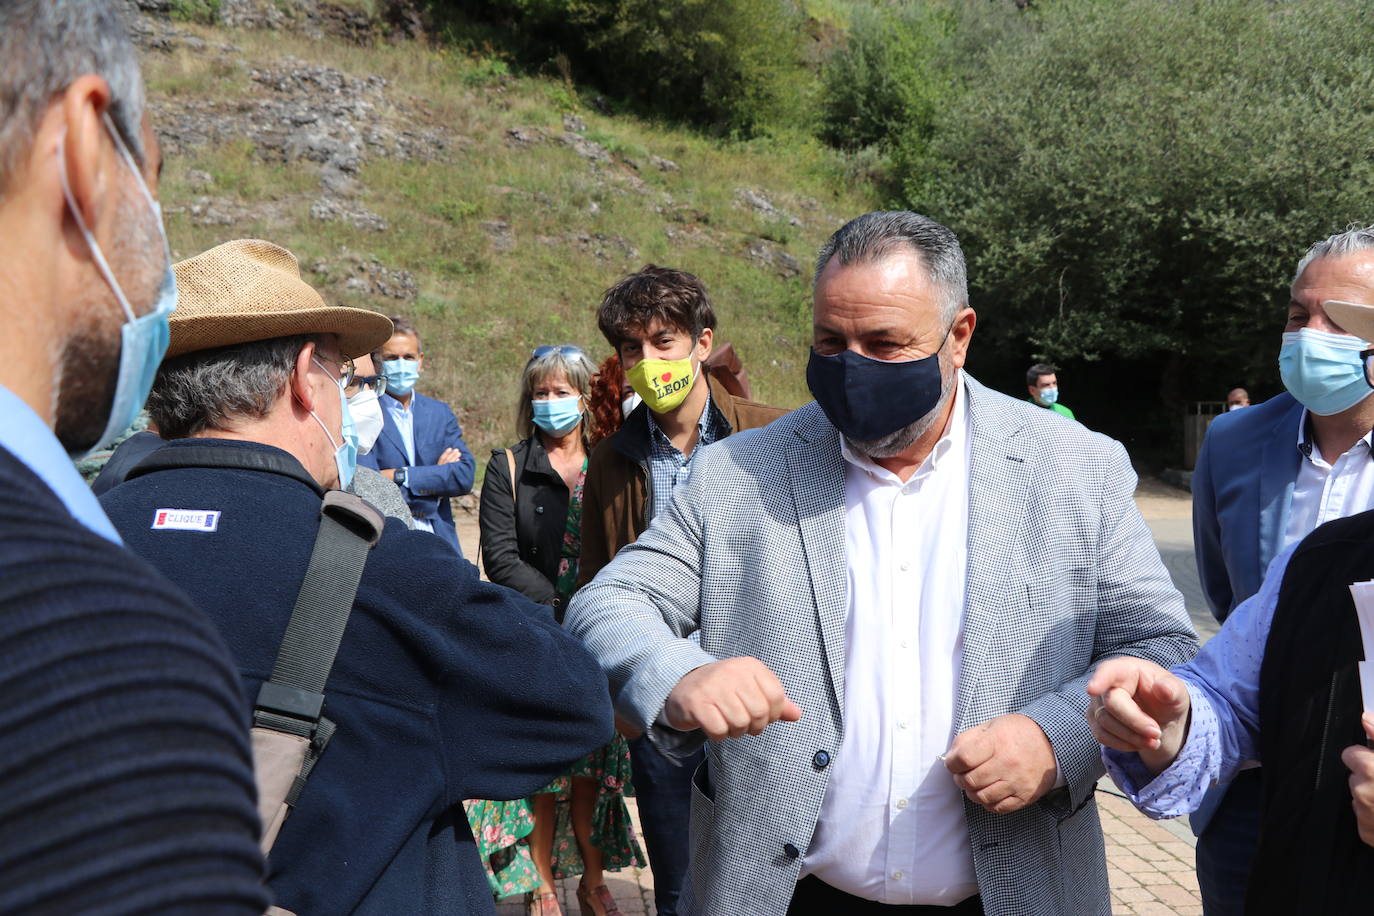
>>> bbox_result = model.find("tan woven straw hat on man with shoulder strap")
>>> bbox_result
[166,239,392,358]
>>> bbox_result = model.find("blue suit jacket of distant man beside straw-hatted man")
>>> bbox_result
[357,391,477,556]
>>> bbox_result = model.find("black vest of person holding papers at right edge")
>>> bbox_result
[1245,512,1374,916]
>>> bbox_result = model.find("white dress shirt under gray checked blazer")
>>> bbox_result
[802,372,978,905]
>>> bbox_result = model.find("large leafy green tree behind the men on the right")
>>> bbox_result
[899,0,1374,453]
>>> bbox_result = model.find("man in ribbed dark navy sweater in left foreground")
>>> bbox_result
[0,0,269,916]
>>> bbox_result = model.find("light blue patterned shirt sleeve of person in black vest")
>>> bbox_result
[1102,541,1301,818]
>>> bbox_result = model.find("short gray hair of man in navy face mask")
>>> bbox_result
[813,210,969,324]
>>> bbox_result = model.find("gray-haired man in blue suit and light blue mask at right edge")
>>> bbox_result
[1193,228,1374,916]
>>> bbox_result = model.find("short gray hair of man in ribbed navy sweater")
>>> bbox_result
[0,0,144,191]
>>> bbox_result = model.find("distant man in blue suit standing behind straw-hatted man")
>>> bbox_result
[359,317,477,556]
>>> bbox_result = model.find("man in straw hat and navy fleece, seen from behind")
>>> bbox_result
[103,240,611,916]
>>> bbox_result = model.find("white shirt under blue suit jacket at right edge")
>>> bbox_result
[1283,411,1374,547]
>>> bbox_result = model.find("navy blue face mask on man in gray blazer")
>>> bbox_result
[807,331,949,442]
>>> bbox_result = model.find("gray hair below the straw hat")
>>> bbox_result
[148,334,322,439]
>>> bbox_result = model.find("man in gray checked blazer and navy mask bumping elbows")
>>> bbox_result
[567,213,1197,916]
